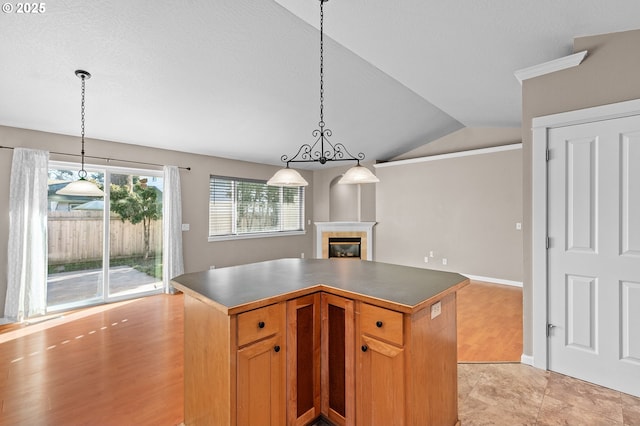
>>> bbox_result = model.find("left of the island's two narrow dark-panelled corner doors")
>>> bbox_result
[287,293,320,426]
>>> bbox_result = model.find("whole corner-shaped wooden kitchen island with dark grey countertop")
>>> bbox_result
[173,259,468,426]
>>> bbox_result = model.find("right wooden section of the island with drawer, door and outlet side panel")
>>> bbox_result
[356,293,458,426]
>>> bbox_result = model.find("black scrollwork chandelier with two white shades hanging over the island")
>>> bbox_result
[267,0,380,186]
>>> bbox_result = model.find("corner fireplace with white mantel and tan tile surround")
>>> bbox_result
[315,222,376,260]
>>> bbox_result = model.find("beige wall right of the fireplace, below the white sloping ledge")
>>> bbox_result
[374,145,522,282]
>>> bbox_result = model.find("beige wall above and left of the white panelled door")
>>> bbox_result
[522,30,640,355]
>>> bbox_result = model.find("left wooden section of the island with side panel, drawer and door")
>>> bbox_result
[184,294,286,426]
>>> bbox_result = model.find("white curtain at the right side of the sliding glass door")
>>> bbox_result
[162,166,184,293]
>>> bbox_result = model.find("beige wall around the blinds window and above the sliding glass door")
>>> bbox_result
[0,126,314,317]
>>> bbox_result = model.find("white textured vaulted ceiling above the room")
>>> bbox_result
[0,0,640,168]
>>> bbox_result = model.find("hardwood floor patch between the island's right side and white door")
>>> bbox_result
[457,281,522,362]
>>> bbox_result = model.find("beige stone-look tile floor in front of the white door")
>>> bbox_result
[458,363,640,426]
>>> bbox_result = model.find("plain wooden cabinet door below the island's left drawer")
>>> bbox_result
[237,334,286,426]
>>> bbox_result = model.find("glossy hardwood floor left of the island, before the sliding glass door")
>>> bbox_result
[0,295,184,426]
